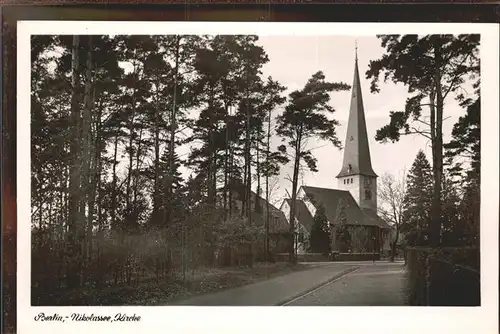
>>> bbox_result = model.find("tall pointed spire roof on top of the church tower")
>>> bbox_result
[337,55,377,178]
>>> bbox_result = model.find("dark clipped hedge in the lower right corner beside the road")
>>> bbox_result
[407,247,481,306]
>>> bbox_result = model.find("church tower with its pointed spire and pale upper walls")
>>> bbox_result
[337,45,377,211]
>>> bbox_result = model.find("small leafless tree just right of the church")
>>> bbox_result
[378,171,406,262]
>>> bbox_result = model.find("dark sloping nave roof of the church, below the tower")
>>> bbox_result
[296,186,390,229]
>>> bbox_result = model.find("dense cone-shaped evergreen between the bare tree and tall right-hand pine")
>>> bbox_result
[402,150,433,244]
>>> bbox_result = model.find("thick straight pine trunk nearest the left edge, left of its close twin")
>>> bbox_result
[66,35,82,288]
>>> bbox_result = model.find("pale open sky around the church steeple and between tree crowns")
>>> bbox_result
[216,36,464,205]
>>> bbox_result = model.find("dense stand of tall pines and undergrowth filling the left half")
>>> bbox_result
[31,35,285,301]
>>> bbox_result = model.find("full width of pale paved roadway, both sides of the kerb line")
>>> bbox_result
[167,261,404,306]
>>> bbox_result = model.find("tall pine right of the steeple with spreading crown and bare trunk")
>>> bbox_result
[366,35,480,247]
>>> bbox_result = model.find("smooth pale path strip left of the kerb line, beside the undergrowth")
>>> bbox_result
[168,262,359,306]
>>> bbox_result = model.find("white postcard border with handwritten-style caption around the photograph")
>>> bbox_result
[17,21,499,334]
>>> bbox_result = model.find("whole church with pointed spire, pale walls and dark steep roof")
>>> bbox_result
[280,53,392,256]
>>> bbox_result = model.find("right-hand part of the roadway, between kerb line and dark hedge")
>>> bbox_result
[284,262,405,306]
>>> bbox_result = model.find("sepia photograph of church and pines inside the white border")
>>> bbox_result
[14,22,498,334]
